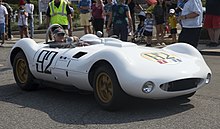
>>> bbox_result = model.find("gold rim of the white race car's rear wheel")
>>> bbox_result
[16,59,28,83]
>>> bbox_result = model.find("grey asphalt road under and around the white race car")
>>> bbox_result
[0,35,220,129]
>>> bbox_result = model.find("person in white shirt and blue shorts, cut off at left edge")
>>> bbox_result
[0,0,8,45]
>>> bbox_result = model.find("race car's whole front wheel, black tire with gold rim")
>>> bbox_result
[93,65,127,111]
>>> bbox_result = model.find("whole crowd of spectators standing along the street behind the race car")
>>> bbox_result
[0,0,220,48]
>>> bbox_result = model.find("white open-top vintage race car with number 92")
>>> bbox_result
[9,25,212,110]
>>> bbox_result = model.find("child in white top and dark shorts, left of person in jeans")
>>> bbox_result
[18,5,28,38]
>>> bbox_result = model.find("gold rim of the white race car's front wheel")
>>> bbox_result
[96,73,113,103]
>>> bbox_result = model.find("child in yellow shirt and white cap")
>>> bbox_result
[168,9,177,43]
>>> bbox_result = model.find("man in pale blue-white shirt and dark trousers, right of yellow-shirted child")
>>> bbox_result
[178,0,203,48]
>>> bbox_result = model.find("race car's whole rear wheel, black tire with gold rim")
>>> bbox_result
[13,51,38,91]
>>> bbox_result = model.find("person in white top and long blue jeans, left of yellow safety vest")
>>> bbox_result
[25,0,34,38]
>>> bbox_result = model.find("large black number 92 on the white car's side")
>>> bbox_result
[36,50,58,74]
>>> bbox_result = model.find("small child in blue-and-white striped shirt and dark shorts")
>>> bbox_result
[143,12,154,46]
